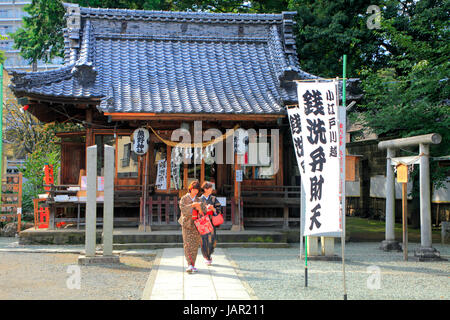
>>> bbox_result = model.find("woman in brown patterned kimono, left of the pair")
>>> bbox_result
[178,181,206,273]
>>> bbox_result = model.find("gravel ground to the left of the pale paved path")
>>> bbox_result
[0,238,154,300]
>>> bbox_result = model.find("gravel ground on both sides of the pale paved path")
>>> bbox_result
[0,238,450,300]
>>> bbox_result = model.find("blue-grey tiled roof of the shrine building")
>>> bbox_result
[7,5,315,114]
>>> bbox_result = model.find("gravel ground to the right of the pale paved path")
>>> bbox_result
[227,242,450,300]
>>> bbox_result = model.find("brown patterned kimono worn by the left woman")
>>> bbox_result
[178,193,206,266]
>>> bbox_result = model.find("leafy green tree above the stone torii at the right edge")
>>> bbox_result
[358,0,450,204]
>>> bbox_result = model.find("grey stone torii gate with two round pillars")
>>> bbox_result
[378,133,442,261]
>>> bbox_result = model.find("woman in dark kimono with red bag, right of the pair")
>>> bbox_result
[200,182,222,266]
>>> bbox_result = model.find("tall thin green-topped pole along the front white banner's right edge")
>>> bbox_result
[339,54,347,300]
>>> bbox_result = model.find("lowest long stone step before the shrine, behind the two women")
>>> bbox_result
[113,242,289,250]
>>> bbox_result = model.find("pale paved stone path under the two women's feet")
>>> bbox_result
[142,248,251,300]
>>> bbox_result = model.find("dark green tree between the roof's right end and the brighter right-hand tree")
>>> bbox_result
[288,0,398,78]
